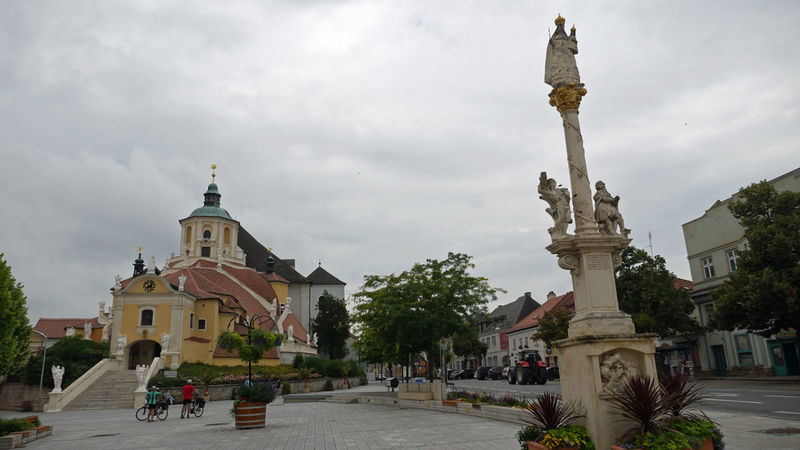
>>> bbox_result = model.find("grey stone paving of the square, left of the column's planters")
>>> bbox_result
[17,401,519,450]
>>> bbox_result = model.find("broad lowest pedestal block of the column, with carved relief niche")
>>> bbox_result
[555,334,656,449]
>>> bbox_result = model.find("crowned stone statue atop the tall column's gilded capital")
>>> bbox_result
[544,16,581,89]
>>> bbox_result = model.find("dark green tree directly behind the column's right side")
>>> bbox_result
[616,247,702,336]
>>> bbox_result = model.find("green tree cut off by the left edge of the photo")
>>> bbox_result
[0,253,32,376]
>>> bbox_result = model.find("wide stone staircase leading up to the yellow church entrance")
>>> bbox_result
[64,370,139,411]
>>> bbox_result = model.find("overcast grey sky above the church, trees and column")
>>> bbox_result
[0,0,800,322]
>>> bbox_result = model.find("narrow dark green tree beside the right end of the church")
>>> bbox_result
[311,291,350,359]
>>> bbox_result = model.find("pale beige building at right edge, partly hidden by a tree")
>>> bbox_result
[683,168,800,376]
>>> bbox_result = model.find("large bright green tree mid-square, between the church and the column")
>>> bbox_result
[353,253,500,376]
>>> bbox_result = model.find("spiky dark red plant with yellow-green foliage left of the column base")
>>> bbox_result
[517,392,594,450]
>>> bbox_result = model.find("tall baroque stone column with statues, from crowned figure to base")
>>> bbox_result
[539,16,656,449]
